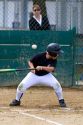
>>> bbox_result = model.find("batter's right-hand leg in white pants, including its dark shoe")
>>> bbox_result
[40,73,66,107]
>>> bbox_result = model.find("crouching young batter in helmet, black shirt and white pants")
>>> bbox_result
[10,43,66,107]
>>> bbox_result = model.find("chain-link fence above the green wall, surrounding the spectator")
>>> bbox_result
[0,0,83,34]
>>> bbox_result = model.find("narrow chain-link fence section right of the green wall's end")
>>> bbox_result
[75,34,83,85]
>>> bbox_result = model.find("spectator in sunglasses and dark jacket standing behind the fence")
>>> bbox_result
[29,4,50,30]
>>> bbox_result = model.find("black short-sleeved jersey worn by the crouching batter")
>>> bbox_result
[30,52,57,76]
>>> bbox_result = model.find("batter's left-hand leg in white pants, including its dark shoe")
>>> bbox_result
[10,72,39,106]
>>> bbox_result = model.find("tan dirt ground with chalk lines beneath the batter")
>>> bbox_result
[0,87,83,125]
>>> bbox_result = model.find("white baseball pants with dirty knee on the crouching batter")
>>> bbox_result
[16,72,63,101]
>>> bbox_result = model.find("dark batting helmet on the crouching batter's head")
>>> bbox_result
[47,43,62,56]
